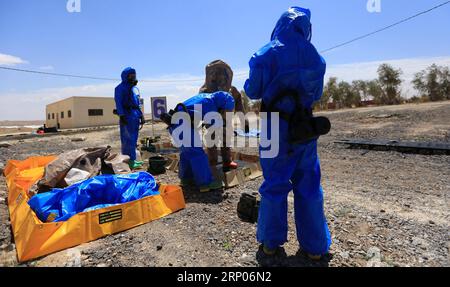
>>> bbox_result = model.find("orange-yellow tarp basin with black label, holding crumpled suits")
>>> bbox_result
[4,156,185,262]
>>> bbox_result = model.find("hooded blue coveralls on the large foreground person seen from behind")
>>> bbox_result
[245,7,331,255]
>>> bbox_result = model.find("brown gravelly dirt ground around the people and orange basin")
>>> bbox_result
[0,101,450,266]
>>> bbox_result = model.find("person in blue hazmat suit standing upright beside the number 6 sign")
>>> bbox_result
[114,67,145,169]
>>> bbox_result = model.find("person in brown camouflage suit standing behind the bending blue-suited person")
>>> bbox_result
[200,60,243,172]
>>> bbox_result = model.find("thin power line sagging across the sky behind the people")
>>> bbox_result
[0,1,450,83]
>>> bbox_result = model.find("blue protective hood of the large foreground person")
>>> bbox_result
[271,7,312,41]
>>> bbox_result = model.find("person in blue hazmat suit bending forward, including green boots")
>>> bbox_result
[161,91,234,192]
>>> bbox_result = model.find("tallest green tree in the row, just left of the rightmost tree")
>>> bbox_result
[378,64,403,105]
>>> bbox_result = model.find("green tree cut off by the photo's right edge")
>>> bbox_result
[412,64,450,101]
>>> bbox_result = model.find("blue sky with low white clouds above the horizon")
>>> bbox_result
[0,0,450,120]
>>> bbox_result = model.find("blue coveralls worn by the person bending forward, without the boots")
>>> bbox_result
[169,92,234,187]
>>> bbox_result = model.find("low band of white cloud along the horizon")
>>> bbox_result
[0,57,450,120]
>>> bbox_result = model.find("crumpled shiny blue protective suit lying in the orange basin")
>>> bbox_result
[28,172,159,222]
